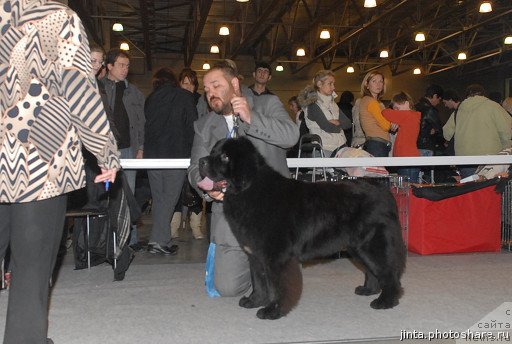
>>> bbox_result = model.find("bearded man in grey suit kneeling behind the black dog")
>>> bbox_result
[189,62,299,296]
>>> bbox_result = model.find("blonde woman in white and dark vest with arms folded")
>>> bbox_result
[297,70,352,157]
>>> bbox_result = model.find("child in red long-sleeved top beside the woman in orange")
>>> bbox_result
[382,92,421,183]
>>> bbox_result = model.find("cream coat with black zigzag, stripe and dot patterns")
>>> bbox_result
[0,0,120,203]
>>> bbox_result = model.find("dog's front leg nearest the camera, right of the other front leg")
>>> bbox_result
[256,257,302,320]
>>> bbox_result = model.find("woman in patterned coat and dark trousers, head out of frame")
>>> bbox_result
[0,0,119,344]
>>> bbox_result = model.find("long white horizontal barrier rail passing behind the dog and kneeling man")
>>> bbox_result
[121,155,512,170]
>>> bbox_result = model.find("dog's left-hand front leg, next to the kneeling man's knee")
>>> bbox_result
[238,255,269,308]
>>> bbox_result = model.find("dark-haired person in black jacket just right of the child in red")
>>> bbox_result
[415,85,444,156]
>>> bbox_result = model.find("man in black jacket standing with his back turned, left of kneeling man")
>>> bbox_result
[144,68,197,255]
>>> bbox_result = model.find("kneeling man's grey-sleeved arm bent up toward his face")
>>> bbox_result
[239,95,299,148]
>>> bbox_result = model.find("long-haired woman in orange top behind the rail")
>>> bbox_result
[359,71,398,157]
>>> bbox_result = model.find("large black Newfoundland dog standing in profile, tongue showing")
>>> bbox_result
[199,137,406,319]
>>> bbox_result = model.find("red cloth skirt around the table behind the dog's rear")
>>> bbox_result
[408,186,501,254]
